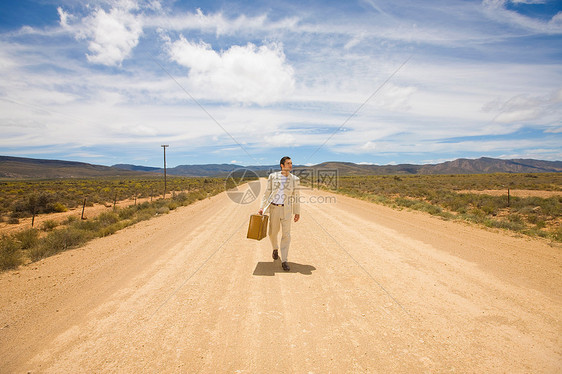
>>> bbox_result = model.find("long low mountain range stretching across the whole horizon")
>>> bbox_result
[0,156,562,179]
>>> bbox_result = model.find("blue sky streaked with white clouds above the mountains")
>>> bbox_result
[0,0,562,166]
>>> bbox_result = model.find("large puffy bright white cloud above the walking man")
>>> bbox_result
[167,36,295,105]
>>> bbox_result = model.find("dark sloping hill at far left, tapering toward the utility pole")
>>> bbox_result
[0,156,146,179]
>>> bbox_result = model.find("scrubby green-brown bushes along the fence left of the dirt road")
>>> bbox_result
[0,174,253,270]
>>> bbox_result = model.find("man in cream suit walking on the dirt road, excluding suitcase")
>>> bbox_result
[258,156,300,271]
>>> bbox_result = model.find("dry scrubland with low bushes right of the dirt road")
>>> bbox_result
[318,173,562,242]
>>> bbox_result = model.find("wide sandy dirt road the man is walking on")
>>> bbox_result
[0,180,562,373]
